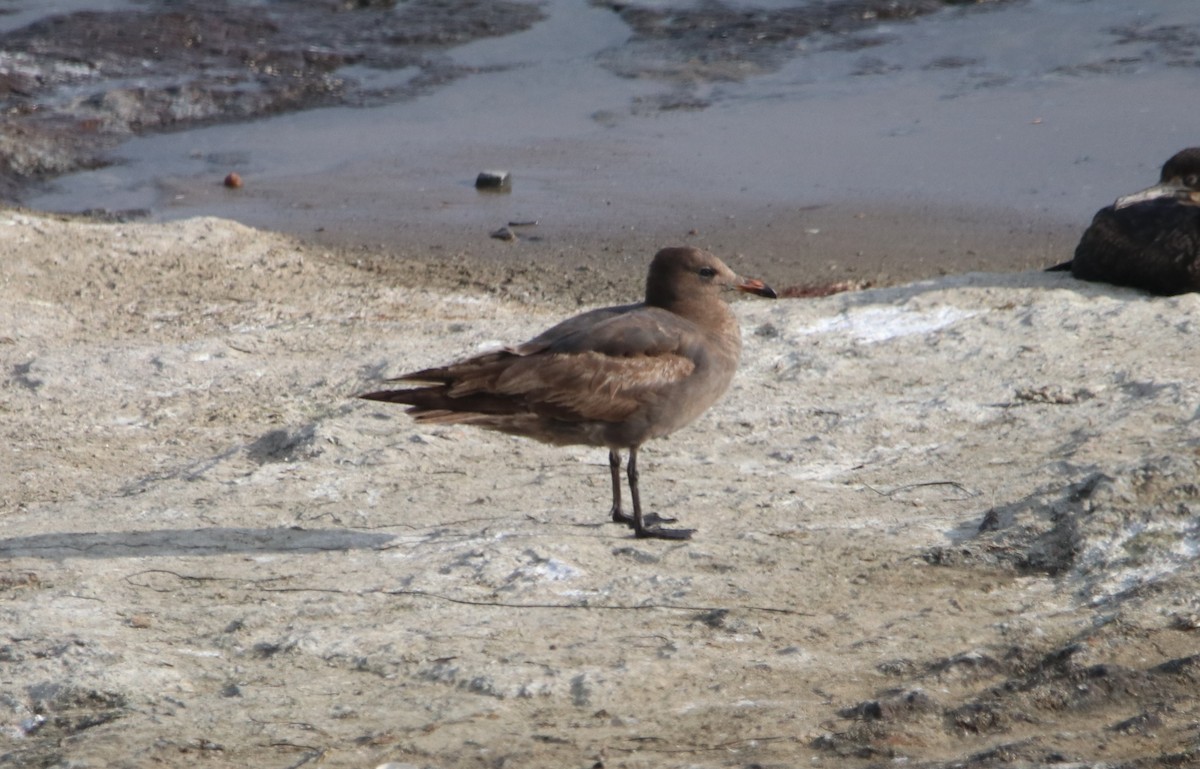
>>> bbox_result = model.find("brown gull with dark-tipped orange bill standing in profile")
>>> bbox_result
[359,247,775,540]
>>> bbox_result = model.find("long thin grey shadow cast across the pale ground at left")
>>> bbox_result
[0,527,392,559]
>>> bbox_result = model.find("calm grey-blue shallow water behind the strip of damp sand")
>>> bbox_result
[16,0,1200,263]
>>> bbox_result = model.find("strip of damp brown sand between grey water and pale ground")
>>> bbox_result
[297,196,1079,306]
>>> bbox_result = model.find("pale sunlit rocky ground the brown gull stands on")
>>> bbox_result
[0,210,1200,768]
